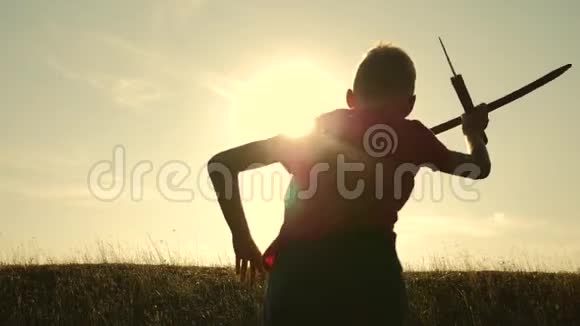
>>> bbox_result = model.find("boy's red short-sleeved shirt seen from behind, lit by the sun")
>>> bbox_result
[264,109,448,268]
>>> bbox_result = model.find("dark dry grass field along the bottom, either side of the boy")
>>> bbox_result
[0,264,580,325]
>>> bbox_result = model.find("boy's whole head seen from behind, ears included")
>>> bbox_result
[346,44,416,118]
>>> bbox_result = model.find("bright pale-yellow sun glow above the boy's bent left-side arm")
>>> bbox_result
[233,61,342,139]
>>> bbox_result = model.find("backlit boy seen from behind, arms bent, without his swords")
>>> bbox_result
[208,45,491,326]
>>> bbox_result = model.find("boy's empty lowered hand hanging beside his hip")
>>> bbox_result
[233,235,265,284]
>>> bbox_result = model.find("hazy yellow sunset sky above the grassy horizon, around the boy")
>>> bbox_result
[0,0,580,269]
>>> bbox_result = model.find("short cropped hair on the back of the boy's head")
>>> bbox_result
[353,43,417,97]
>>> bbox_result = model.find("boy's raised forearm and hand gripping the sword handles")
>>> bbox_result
[438,104,491,179]
